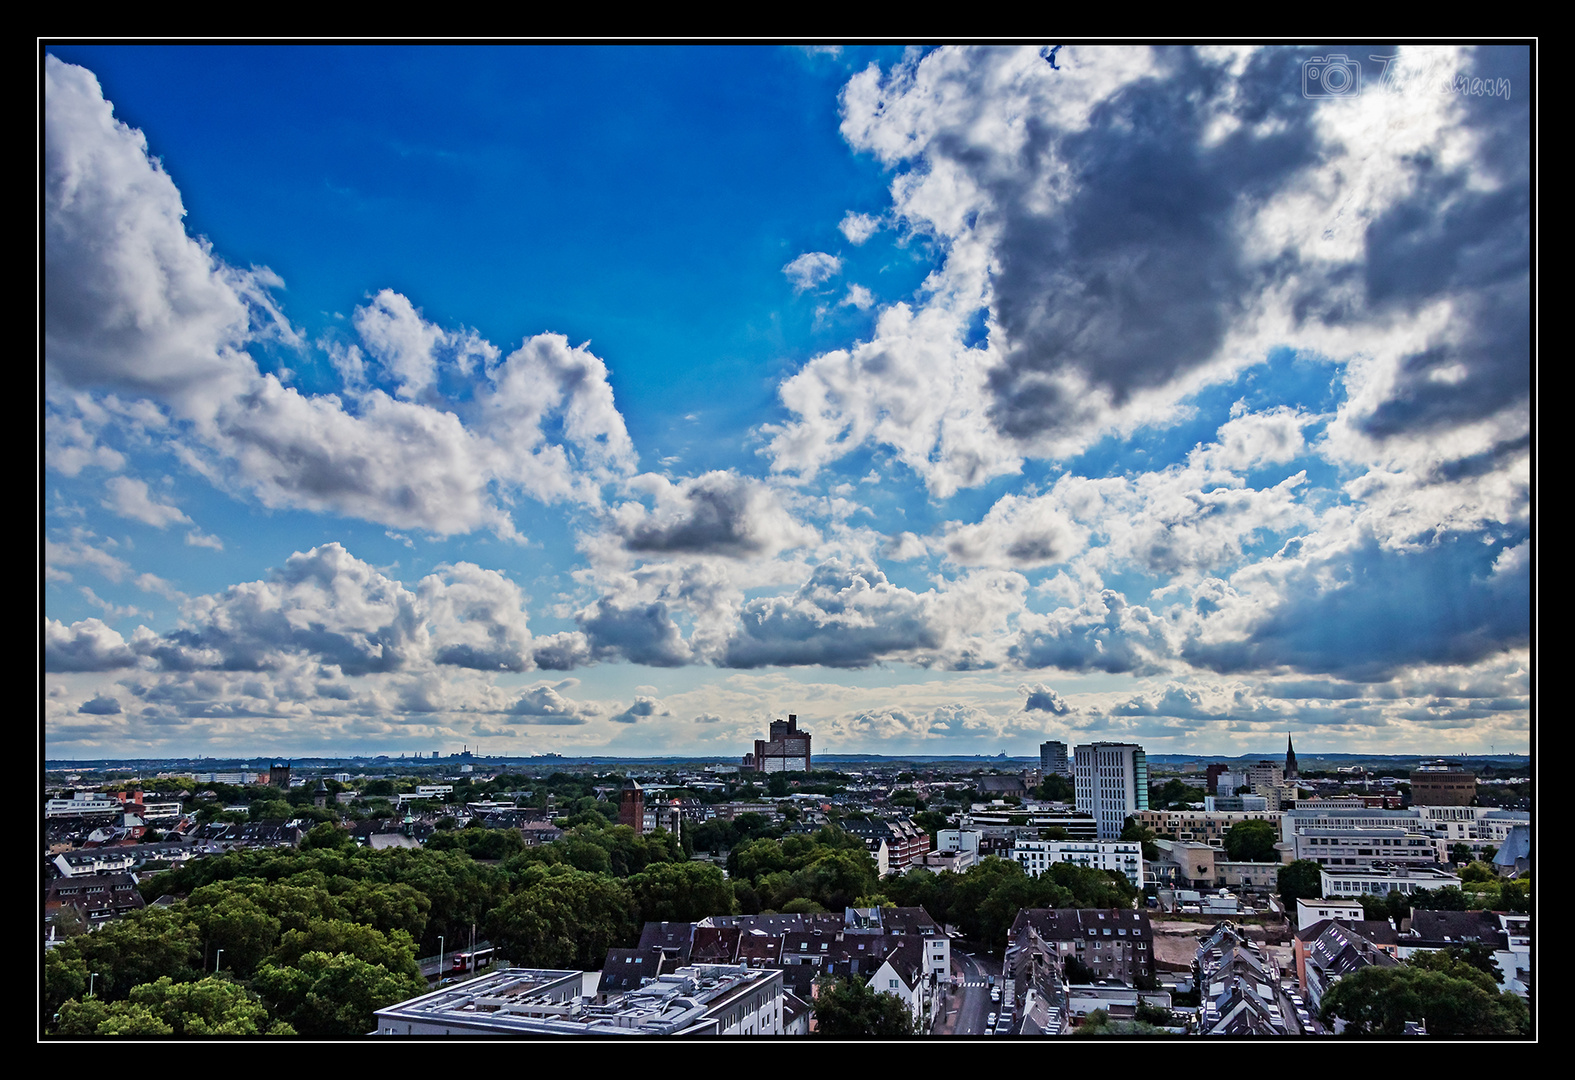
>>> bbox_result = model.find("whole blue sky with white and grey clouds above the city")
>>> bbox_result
[38,43,1534,760]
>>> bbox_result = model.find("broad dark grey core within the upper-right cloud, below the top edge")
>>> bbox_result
[989,49,1321,438]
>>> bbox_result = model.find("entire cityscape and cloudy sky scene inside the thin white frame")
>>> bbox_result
[38,39,1539,1045]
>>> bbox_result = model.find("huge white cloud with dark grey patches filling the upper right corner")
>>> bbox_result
[769,47,1529,496]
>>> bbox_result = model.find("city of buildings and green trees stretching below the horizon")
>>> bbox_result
[44,727,1532,1039]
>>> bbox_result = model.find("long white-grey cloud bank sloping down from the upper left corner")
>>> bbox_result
[44,57,635,537]
